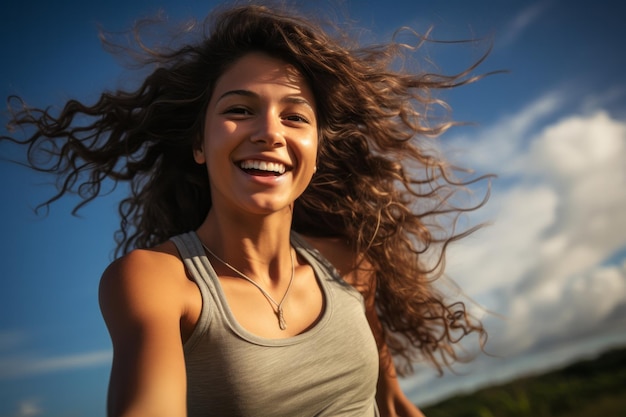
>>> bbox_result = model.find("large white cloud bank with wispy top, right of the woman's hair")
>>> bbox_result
[406,93,626,400]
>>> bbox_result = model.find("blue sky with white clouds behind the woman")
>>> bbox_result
[0,0,626,417]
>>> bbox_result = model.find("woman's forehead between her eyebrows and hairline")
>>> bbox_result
[213,52,314,105]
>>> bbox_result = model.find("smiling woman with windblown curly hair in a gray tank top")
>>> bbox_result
[5,6,484,417]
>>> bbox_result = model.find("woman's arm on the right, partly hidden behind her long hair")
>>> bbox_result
[307,237,424,417]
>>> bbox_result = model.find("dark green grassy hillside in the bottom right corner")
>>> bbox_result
[423,348,626,417]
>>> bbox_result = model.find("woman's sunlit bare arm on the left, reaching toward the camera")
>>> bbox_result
[99,251,186,416]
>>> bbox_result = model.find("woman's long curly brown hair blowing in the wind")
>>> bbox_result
[2,5,486,373]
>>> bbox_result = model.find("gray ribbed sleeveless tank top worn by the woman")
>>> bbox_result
[172,232,379,417]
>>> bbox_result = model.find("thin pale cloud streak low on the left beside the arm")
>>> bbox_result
[0,350,112,379]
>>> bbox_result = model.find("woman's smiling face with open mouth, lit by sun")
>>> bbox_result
[194,53,318,214]
